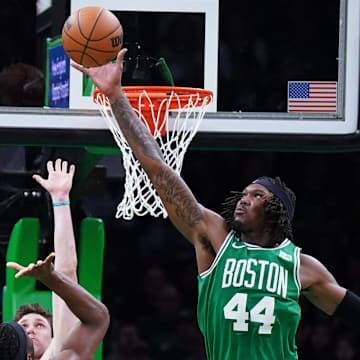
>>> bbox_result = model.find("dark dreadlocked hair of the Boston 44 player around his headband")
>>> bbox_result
[221,176,296,243]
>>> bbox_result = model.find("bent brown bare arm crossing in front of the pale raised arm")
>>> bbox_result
[7,253,110,360]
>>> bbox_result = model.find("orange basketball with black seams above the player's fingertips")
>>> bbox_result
[62,6,123,67]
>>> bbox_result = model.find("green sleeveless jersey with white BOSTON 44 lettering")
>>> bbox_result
[198,231,301,360]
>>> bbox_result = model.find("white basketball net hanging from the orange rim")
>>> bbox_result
[94,89,211,220]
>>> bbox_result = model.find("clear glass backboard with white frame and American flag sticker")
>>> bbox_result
[0,0,360,148]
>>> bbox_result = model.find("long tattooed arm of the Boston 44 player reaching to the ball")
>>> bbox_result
[72,49,227,255]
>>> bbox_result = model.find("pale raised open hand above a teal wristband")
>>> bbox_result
[32,159,75,202]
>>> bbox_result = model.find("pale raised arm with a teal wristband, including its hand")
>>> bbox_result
[33,159,78,360]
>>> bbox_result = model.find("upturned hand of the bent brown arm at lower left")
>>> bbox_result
[6,253,55,281]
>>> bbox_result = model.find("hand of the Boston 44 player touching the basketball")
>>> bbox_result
[71,48,127,103]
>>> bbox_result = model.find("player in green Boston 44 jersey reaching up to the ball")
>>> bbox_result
[72,49,360,360]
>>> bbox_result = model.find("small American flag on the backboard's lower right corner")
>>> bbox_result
[288,81,337,113]
